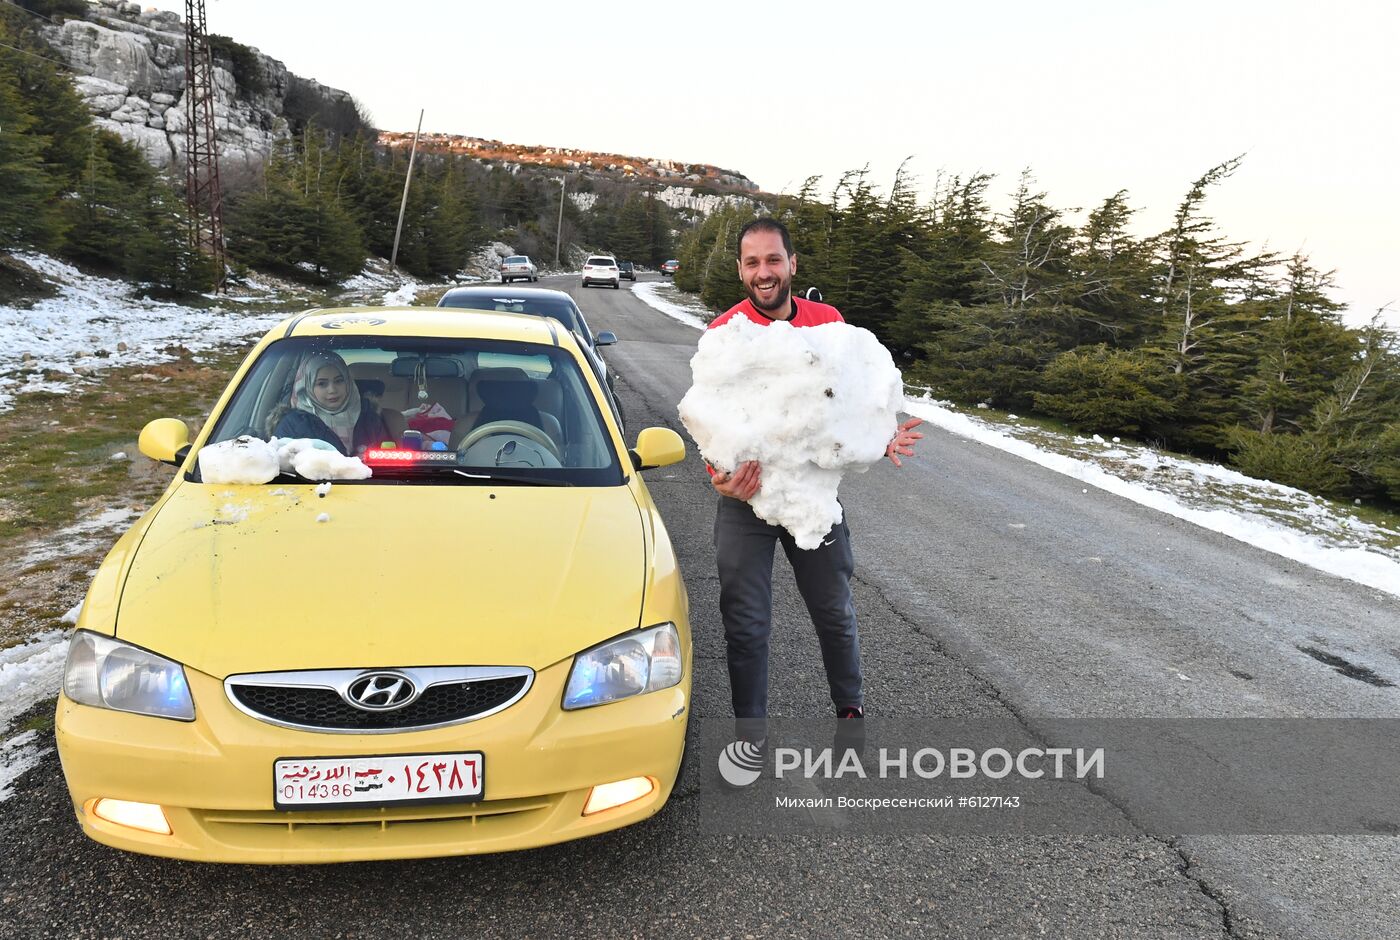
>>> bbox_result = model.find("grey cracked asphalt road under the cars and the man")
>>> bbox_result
[0,276,1400,939]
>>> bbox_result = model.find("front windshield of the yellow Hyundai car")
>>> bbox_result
[206,336,623,486]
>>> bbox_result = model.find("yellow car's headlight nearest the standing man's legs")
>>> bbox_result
[564,623,680,709]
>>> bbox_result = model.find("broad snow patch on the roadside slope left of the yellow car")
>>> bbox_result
[0,252,283,410]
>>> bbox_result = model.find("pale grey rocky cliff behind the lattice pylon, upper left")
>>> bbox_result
[42,0,353,168]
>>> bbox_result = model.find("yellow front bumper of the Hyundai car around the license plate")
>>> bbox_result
[55,661,690,864]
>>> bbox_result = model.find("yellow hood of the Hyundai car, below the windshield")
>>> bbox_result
[116,483,645,678]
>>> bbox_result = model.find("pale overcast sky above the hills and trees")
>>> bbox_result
[155,0,1400,326]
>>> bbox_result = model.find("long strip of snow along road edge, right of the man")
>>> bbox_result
[906,396,1400,597]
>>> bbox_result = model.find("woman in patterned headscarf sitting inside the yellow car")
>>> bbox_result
[273,352,389,457]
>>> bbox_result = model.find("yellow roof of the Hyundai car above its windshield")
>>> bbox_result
[267,307,575,346]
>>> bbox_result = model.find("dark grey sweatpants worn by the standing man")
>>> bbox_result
[714,496,862,719]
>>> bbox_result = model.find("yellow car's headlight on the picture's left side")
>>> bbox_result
[63,630,195,721]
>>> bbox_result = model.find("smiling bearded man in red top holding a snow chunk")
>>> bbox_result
[710,219,923,741]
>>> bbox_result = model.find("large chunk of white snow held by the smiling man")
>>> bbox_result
[680,317,904,549]
